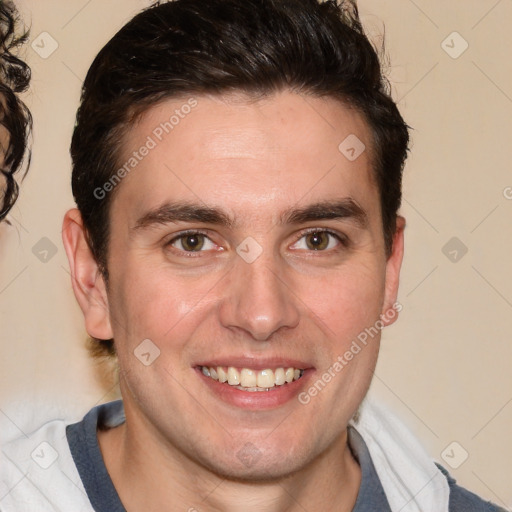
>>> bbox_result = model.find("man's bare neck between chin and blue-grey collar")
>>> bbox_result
[98,418,361,512]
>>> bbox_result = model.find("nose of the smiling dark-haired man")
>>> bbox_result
[219,251,300,341]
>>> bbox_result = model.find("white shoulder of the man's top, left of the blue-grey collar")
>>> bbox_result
[0,414,92,512]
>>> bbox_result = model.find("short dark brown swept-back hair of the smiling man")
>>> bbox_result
[71,0,409,352]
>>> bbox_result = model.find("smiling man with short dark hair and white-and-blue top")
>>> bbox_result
[0,0,504,512]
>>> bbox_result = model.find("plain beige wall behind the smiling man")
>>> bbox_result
[0,0,512,506]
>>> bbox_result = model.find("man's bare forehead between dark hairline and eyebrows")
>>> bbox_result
[112,92,379,224]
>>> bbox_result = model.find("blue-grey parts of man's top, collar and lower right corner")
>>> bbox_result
[66,401,505,512]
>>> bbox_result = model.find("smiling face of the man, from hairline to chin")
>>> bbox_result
[65,92,402,479]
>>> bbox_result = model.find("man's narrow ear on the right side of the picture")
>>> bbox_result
[381,216,405,325]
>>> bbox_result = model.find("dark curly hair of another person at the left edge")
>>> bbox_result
[0,0,32,220]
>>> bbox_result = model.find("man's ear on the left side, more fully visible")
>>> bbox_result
[62,209,113,340]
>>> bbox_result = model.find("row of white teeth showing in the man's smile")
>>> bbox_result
[199,366,304,392]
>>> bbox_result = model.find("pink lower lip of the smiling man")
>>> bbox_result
[195,368,314,410]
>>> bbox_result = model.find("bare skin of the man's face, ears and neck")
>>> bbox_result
[63,91,404,512]
